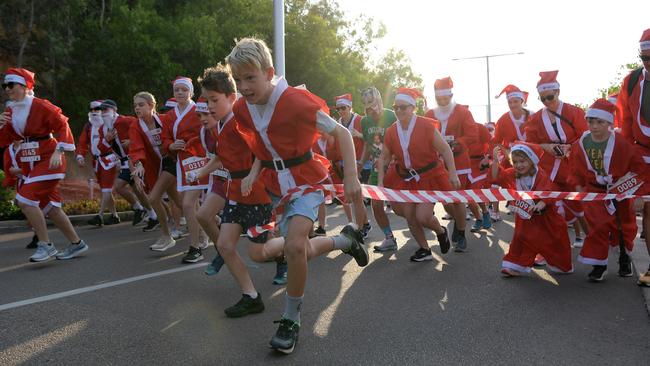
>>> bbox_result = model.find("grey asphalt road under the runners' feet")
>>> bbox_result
[0,208,650,365]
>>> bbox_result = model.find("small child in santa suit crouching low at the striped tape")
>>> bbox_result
[491,142,573,277]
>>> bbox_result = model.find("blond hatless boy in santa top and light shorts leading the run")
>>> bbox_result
[226,38,368,353]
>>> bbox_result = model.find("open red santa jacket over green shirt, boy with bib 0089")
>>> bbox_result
[571,131,650,192]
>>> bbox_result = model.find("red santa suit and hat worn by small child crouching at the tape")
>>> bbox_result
[495,144,573,272]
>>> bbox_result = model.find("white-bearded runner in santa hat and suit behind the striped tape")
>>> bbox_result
[425,77,478,252]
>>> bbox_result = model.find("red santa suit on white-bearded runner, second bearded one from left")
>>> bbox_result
[77,115,120,192]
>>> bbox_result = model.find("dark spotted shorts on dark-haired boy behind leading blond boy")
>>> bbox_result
[221,201,273,244]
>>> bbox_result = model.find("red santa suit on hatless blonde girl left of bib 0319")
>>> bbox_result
[129,114,163,192]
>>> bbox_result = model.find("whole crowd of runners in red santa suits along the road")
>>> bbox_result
[0,29,650,353]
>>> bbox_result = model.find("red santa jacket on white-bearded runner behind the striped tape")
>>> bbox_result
[425,104,478,175]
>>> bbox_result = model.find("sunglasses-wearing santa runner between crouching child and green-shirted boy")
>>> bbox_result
[525,71,588,247]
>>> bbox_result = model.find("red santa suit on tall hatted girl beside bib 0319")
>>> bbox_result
[162,100,208,192]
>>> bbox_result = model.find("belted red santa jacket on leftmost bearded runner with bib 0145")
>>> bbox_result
[0,97,75,184]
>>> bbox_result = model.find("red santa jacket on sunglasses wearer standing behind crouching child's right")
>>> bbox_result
[526,102,588,184]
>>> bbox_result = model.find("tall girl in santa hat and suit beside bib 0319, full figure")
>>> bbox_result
[162,77,208,263]
